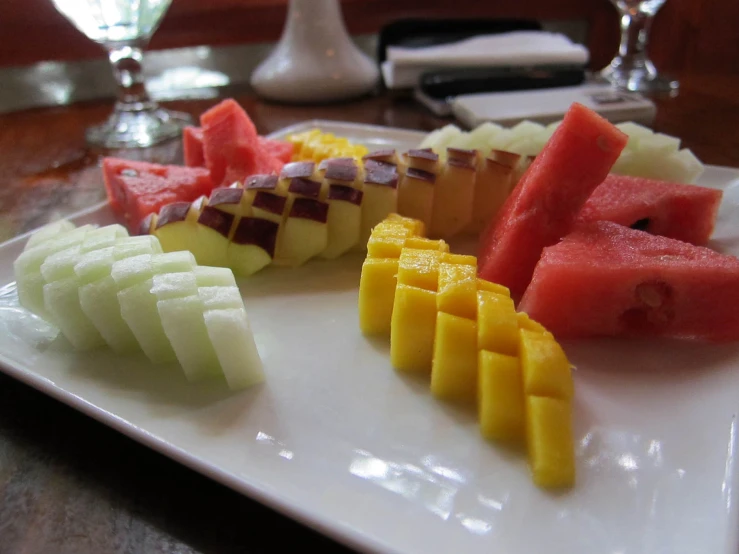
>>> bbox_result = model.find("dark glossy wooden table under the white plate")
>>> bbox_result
[0,75,739,554]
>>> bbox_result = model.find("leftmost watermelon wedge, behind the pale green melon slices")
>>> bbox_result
[103,158,213,234]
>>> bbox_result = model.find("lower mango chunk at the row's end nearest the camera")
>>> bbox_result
[526,396,575,488]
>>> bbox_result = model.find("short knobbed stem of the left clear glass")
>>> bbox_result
[108,44,156,112]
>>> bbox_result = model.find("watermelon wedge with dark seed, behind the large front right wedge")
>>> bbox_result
[577,175,722,245]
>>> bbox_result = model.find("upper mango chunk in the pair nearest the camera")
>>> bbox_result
[520,329,574,400]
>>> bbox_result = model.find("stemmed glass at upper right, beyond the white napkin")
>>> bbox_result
[601,0,678,93]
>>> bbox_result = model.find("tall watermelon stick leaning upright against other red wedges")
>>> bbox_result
[478,103,628,296]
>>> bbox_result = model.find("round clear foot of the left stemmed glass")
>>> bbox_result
[85,108,192,148]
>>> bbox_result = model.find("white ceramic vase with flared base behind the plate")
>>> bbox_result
[251,0,379,103]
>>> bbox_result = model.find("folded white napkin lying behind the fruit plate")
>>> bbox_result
[382,31,589,89]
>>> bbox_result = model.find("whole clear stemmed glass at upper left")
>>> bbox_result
[52,0,190,148]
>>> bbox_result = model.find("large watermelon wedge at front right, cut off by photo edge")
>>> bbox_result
[519,221,739,342]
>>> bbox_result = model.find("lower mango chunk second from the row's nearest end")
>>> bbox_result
[478,350,526,443]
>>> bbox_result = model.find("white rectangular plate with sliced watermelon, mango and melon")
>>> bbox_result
[0,101,739,552]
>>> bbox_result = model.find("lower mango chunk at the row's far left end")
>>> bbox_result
[359,258,398,336]
